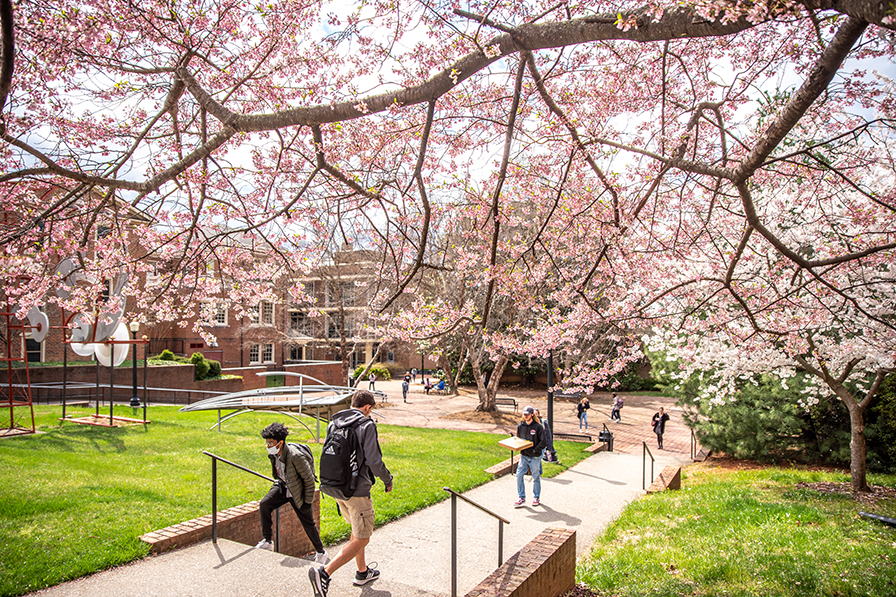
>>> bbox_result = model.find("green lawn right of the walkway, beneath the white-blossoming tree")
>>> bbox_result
[576,468,896,597]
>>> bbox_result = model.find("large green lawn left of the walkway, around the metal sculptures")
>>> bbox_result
[0,406,584,596]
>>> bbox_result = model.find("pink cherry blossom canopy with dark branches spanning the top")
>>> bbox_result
[0,0,896,438]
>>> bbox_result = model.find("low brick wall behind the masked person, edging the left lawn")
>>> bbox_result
[140,491,320,557]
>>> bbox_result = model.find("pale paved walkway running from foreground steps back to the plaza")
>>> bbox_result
[26,382,689,597]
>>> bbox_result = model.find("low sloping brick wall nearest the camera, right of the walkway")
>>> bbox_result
[466,528,576,597]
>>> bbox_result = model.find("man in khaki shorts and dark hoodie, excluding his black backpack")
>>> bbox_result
[308,390,393,597]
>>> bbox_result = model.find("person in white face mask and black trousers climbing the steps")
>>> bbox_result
[255,423,327,564]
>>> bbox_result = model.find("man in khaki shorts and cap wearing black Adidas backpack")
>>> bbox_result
[308,390,393,597]
